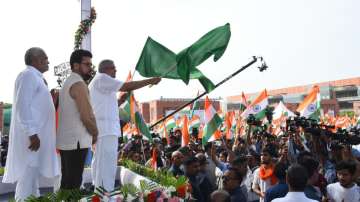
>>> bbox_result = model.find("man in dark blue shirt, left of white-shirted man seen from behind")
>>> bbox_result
[264,162,289,202]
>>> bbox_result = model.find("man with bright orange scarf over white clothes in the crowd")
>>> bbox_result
[252,147,277,202]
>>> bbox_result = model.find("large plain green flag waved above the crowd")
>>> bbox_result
[136,24,231,92]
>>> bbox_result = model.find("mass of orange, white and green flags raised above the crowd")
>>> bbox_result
[123,86,360,152]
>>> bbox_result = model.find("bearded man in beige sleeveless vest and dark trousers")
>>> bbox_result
[56,49,98,189]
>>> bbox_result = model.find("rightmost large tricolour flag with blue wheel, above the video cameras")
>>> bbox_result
[296,85,320,120]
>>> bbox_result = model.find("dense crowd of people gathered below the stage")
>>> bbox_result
[119,117,360,202]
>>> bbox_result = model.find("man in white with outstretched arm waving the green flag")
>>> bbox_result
[89,60,161,191]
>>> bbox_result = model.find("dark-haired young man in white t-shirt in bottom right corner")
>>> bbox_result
[326,161,360,202]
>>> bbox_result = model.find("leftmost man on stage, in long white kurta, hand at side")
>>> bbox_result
[3,47,60,201]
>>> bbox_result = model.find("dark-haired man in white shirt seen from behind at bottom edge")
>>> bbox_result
[272,164,316,202]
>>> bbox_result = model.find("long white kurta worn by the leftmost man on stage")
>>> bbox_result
[3,66,60,183]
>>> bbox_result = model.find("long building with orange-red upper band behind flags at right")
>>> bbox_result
[226,77,360,115]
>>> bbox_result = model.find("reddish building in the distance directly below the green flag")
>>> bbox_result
[139,97,221,123]
